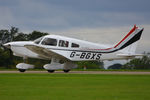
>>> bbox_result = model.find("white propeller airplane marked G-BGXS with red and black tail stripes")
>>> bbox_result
[4,25,144,73]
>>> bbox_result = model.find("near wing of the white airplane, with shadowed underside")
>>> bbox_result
[24,45,69,61]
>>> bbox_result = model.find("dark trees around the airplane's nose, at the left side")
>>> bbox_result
[0,27,49,68]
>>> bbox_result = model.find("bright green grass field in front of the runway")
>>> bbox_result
[0,73,150,100]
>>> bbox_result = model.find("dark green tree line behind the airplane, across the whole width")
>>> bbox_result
[0,27,150,69]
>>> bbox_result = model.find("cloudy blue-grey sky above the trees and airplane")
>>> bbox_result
[0,0,150,67]
